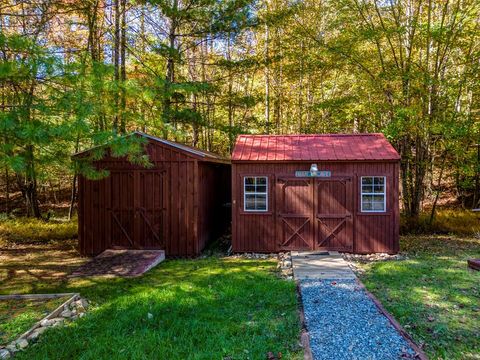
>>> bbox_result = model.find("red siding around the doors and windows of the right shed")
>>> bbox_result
[232,161,399,253]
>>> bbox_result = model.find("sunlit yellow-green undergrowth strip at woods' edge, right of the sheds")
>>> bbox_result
[400,210,480,235]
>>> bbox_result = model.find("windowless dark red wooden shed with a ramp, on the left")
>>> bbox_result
[76,132,231,256]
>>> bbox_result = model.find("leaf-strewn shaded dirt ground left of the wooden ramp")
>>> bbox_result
[0,240,88,294]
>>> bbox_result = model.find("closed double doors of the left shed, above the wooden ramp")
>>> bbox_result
[105,170,166,249]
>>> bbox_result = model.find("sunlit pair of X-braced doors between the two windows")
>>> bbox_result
[276,176,354,251]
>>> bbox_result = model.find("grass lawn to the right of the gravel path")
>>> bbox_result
[362,236,480,359]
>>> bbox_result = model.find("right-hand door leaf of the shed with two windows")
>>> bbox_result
[315,177,353,251]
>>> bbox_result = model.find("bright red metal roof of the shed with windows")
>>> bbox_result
[232,133,400,161]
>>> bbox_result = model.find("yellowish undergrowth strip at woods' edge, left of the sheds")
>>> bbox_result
[0,217,77,246]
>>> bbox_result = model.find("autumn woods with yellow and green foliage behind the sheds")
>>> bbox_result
[0,0,480,217]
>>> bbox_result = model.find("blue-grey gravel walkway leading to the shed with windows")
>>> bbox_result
[300,279,415,360]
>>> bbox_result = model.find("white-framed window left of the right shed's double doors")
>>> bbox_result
[243,176,268,211]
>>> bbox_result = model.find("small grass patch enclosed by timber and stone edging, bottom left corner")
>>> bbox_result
[0,298,66,345]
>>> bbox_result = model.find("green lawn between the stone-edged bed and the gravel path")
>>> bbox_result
[4,258,303,359]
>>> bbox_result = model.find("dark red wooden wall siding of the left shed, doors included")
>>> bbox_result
[79,142,229,256]
